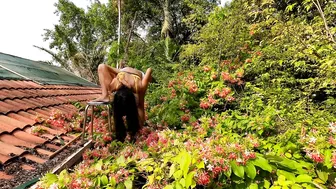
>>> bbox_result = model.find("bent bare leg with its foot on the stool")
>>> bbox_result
[93,64,119,102]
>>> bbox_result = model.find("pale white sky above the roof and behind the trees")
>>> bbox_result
[0,0,229,61]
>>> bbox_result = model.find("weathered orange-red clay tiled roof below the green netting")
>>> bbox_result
[0,80,100,179]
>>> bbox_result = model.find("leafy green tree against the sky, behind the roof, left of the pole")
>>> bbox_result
[38,0,117,82]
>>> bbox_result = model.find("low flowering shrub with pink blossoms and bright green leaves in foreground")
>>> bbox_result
[35,108,336,189]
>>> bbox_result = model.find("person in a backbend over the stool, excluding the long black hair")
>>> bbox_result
[93,64,152,128]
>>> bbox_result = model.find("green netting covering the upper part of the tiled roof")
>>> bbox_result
[0,53,97,87]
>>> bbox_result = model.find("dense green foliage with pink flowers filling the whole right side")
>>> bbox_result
[36,0,336,189]
